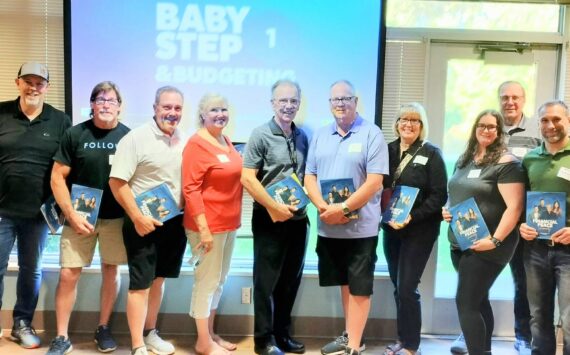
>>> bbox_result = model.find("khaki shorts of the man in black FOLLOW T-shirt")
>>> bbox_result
[59,218,127,267]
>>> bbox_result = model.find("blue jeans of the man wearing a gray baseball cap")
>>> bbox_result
[0,215,48,324]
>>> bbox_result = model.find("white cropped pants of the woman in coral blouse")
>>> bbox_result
[186,229,236,319]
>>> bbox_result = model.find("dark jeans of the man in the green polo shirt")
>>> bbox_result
[524,240,570,355]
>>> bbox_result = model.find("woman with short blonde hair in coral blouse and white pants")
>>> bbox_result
[182,94,243,355]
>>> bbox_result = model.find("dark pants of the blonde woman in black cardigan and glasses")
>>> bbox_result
[383,224,439,351]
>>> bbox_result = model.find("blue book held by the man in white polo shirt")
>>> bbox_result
[135,182,181,222]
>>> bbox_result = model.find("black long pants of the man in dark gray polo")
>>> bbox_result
[252,209,308,346]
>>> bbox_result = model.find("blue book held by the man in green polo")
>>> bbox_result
[526,191,566,239]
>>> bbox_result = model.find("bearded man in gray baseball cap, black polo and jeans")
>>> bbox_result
[0,62,71,348]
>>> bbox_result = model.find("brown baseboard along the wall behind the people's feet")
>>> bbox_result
[1,310,396,339]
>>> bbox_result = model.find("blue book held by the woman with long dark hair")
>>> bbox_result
[449,197,490,251]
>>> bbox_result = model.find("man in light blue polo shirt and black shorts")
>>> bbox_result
[305,80,388,355]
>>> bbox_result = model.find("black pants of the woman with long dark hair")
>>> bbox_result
[451,250,505,355]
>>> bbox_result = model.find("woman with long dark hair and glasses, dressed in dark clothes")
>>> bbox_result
[442,110,525,355]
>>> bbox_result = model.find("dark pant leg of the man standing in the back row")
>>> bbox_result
[509,240,531,342]
